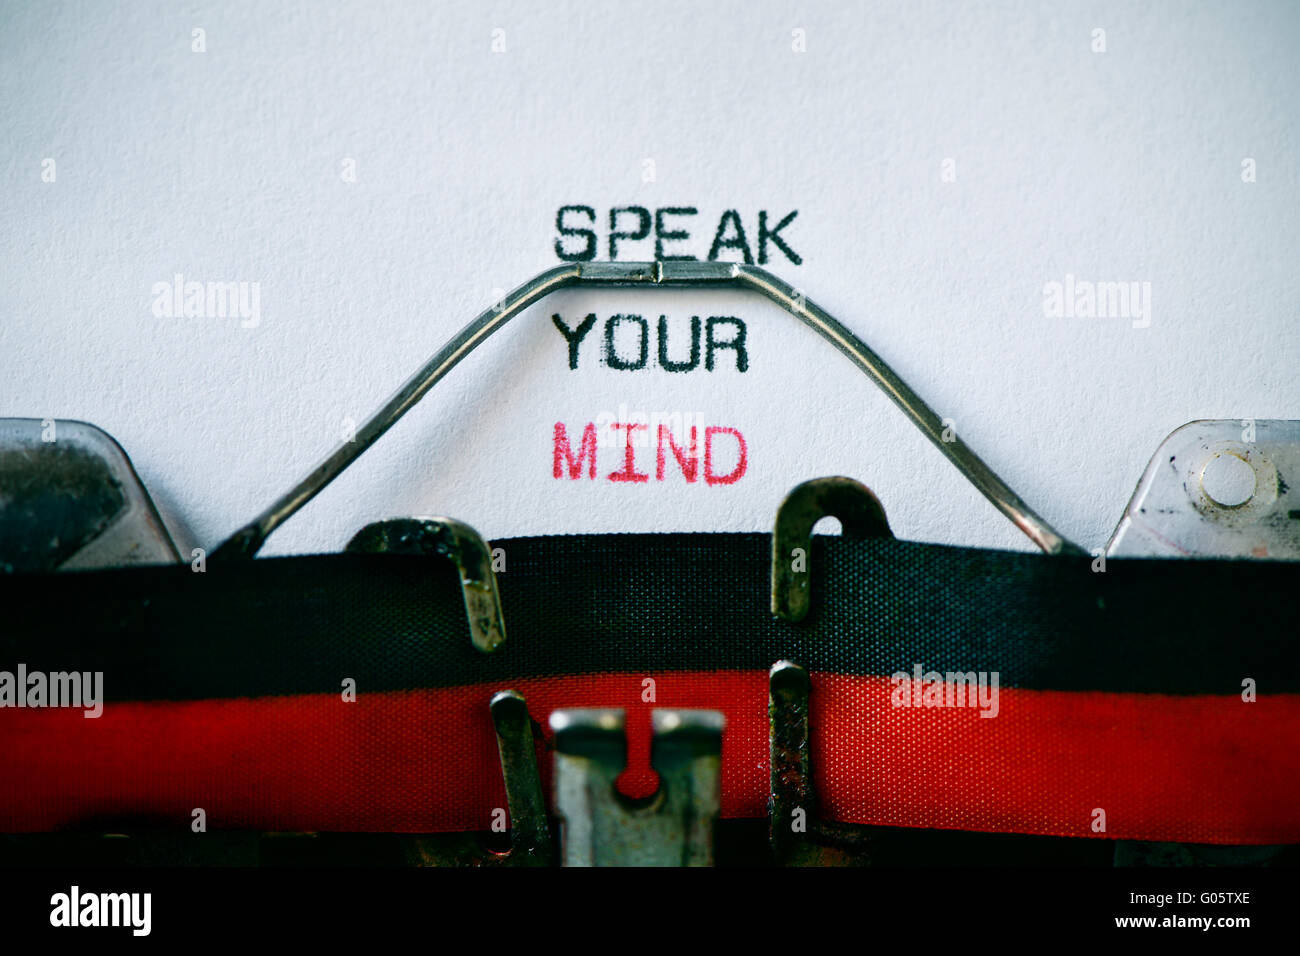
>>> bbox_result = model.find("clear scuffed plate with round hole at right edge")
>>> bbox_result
[1106,419,1300,561]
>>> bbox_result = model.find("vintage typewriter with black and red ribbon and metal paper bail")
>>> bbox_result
[0,261,1300,866]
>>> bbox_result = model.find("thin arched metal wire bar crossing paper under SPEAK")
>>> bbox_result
[209,261,1083,559]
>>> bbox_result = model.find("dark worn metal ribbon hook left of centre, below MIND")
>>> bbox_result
[347,518,506,654]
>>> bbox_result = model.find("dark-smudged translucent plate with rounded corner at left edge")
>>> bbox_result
[0,419,181,574]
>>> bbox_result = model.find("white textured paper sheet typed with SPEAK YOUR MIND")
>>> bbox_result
[0,3,1300,553]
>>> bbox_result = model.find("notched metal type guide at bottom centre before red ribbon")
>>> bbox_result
[551,709,724,866]
